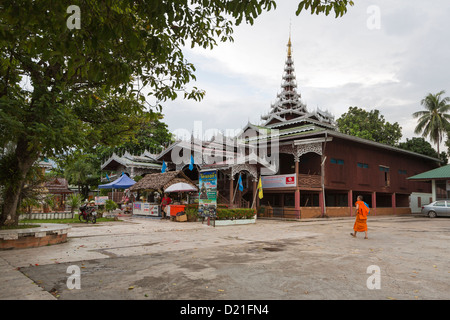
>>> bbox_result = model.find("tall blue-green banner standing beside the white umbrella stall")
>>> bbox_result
[198,170,217,218]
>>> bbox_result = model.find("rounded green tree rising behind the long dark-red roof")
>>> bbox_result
[337,107,402,146]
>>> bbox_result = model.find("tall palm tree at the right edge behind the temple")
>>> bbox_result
[413,90,450,154]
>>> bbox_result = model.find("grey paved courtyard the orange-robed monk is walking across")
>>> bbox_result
[0,216,450,301]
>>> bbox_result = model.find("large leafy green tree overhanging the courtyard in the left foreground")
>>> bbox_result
[0,0,352,226]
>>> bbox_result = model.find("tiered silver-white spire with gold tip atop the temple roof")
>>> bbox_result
[261,37,335,127]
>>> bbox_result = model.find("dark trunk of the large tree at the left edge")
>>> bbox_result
[0,138,39,226]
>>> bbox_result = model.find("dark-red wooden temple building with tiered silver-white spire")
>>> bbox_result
[156,38,440,218]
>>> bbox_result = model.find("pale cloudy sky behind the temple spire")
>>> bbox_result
[158,0,450,146]
